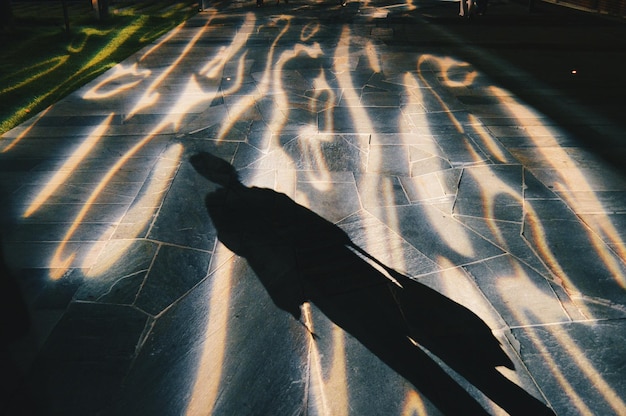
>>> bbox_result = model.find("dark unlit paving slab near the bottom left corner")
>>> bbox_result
[29,302,153,415]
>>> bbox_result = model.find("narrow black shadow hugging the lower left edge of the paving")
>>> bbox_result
[0,235,32,415]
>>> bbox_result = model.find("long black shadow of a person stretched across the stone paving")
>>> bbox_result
[190,153,554,416]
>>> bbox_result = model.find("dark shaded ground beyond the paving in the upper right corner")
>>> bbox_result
[408,0,626,174]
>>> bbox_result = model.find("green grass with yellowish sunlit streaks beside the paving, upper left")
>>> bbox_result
[0,0,198,134]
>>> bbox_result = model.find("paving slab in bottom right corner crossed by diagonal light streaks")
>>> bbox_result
[513,320,625,415]
